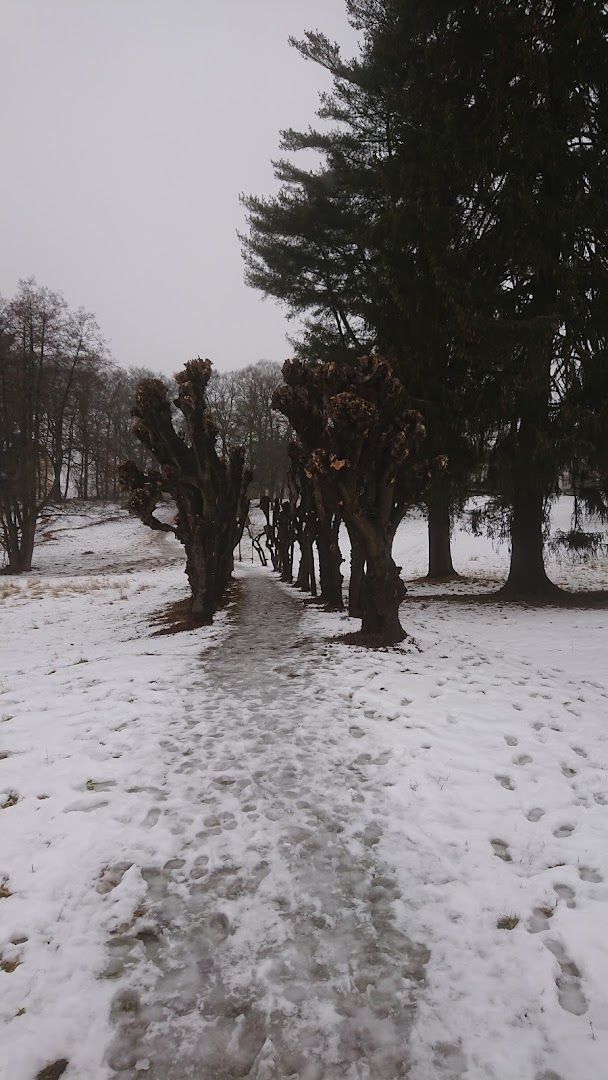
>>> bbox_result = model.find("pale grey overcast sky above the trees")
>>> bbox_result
[0,0,354,372]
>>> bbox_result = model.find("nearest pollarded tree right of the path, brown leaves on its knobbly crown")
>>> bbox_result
[274,356,443,645]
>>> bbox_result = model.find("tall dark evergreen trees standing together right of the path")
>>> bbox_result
[243,0,608,597]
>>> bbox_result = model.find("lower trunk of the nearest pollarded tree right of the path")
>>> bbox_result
[361,549,406,645]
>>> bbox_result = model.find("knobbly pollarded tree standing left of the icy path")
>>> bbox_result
[121,359,252,624]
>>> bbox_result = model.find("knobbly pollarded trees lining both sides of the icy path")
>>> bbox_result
[121,356,429,645]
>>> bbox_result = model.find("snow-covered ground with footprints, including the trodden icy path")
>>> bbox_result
[0,500,608,1080]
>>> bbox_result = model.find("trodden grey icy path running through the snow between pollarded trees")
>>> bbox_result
[108,569,427,1080]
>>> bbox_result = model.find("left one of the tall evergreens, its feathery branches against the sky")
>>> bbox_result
[244,3,483,578]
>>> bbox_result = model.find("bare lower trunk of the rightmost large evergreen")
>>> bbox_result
[500,490,560,599]
